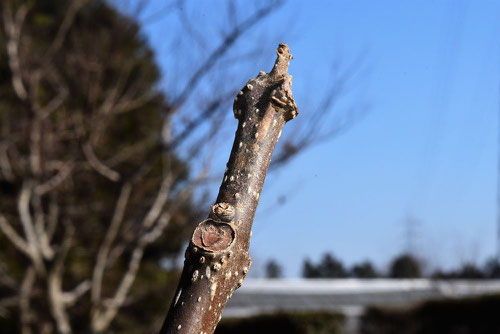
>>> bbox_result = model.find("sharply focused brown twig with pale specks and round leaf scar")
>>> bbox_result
[160,44,298,334]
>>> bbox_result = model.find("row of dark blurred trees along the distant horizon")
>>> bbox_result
[265,253,500,279]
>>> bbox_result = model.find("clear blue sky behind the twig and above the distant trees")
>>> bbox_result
[133,0,500,277]
